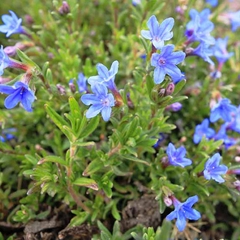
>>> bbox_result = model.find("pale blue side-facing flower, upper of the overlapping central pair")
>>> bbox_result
[88,61,119,92]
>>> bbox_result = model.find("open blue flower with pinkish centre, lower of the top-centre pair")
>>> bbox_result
[151,44,186,84]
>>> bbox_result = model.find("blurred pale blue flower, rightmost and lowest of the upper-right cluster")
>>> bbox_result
[212,37,233,63]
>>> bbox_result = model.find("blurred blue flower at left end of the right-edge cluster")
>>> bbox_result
[193,118,215,144]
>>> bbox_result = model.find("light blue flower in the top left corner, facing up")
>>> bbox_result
[0,11,26,37]
